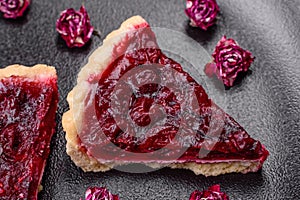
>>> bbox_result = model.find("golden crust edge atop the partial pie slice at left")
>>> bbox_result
[0,64,56,78]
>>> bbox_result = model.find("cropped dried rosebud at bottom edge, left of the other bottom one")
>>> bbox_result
[85,187,119,200]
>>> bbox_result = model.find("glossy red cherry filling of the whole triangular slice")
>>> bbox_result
[79,26,268,163]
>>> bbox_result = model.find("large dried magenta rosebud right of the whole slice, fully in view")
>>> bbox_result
[212,36,254,87]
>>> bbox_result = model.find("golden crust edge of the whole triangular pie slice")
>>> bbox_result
[62,16,260,176]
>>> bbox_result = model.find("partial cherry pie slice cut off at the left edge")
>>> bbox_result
[0,65,58,199]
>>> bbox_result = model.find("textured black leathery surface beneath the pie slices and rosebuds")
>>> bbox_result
[0,0,300,200]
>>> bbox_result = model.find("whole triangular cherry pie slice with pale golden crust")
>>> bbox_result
[63,16,269,176]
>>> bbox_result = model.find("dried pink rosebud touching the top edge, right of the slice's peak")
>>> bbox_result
[185,0,220,30]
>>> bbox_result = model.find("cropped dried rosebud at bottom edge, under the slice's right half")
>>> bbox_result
[190,185,229,200]
